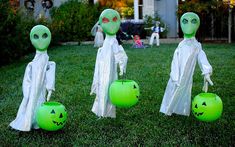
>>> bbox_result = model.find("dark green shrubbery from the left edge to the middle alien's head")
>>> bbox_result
[0,0,103,66]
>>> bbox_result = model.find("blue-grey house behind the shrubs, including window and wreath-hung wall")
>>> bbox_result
[19,0,178,38]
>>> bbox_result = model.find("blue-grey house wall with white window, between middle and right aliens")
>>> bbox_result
[94,0,178,38]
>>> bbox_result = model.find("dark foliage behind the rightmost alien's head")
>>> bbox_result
[177,0,235,40]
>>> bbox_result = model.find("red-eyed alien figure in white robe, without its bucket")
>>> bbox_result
[91,9,128,118]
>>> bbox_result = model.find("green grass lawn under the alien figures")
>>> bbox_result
[0,44,235,146]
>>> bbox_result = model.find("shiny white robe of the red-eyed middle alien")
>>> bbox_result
[91,36,127,117]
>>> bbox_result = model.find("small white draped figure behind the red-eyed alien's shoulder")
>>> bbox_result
[91,22,104,47]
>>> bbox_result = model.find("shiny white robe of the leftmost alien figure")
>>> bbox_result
[10,51,56,131]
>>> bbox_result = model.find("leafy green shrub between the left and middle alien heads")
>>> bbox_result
[51,0,100,42]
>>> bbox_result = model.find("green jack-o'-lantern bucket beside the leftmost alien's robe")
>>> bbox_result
[36,102,67,131]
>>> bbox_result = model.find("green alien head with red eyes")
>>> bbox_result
[99,9,121,36]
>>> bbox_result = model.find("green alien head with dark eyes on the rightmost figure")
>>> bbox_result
[180,12,200,38]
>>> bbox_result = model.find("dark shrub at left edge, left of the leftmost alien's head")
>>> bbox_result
[0,0,35,66]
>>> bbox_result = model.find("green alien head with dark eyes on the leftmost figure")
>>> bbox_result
[30,25,51,51]
